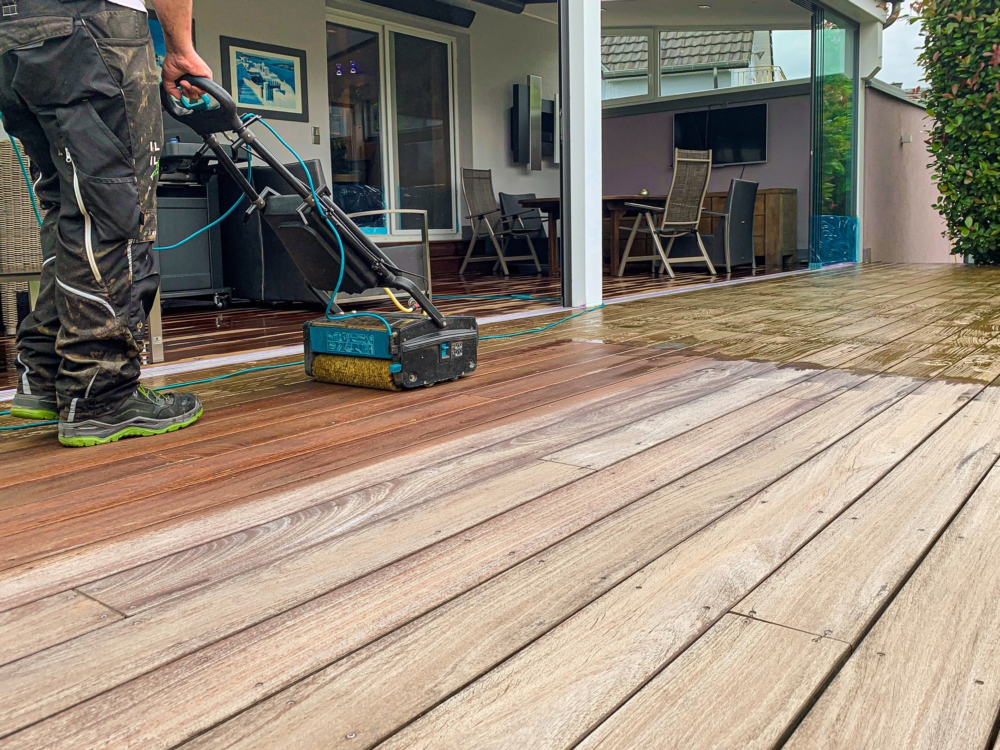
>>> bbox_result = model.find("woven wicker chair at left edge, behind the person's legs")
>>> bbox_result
[0,140,42,335]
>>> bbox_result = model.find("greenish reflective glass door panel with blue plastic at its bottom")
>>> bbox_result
[809,10,858,266]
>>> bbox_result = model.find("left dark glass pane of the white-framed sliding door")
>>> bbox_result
[326,23,387,234]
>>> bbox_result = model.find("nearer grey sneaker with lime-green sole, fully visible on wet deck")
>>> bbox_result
[59,386,202,448]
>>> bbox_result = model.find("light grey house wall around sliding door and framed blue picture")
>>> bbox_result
[194,0,559,235]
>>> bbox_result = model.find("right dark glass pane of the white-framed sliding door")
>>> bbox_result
[391,33,455,231]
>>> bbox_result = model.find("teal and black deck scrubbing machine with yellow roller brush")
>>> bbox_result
[160,76,479,391]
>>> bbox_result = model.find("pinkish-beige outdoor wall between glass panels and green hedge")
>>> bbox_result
[862,88,955,263]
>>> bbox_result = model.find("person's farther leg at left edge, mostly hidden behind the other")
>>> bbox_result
[0,50,62,419]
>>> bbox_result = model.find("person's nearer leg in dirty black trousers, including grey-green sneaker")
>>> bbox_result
[12,2,201,445]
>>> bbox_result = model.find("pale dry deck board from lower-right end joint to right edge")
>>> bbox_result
[736,388,1000,644]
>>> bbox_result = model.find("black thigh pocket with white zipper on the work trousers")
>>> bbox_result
[56,101,142,242]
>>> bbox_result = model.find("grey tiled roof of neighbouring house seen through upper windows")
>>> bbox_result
[601,31,753,73]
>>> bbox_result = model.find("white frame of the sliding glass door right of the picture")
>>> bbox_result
[326,10,461,243]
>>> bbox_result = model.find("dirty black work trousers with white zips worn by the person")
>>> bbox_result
[0,0,163,422]
